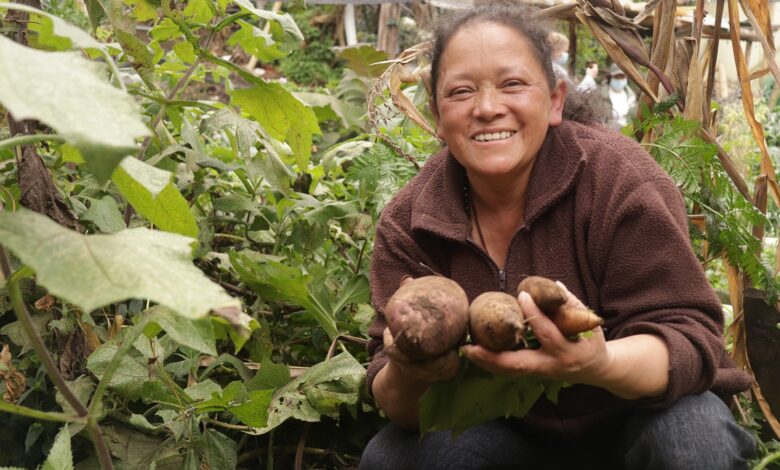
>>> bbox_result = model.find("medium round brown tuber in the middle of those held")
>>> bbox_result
[469,292,525,351]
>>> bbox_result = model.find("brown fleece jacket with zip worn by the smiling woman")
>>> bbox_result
[368,121,751,437]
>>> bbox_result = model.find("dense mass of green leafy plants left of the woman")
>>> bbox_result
[0,0,426,469]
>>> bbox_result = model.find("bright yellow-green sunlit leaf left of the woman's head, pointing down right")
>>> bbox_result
[231,83,321,169]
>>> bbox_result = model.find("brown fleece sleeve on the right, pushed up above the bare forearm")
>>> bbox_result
[591,177,736,408]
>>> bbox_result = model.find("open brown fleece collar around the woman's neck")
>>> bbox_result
[411,121,587,241]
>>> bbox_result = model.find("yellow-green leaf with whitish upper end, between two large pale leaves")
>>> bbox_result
[111,158,198,238]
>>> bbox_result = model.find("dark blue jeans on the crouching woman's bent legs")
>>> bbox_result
[360,392,755,470]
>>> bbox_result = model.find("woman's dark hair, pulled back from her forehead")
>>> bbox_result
[430,1,604,123]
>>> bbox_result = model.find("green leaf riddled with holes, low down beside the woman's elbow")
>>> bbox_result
[258,352,366,433]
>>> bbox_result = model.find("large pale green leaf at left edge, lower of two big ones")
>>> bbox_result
[0,209,240,318]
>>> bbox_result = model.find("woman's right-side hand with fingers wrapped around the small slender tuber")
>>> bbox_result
[461,283,611,384]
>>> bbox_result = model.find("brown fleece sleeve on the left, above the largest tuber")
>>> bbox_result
[366,204,442,393]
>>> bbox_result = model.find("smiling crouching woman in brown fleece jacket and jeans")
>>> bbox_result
[361,5,754,469]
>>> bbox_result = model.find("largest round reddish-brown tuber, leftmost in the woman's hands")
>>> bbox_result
[385,276,469,362]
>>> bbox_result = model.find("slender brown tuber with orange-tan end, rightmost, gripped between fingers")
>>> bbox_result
[517,276,604,336]
